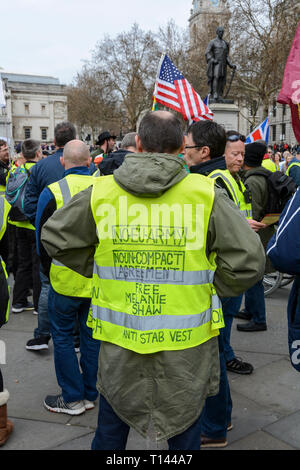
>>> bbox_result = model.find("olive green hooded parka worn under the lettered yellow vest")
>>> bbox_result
[41,154,265,440]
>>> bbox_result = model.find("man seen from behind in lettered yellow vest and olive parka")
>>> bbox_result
[42,111,264,450]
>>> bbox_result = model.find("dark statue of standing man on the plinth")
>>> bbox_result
[205,26,236,102]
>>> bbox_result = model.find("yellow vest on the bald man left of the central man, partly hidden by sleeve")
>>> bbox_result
[48,174,94,298]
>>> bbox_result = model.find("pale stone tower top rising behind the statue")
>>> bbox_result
[189,0,230,41]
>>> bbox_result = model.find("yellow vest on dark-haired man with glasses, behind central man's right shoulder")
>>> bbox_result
[208,170,252,219]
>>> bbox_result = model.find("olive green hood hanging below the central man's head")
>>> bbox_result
[114,153,188,197]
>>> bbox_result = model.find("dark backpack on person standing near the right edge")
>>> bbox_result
[245,170,297,214]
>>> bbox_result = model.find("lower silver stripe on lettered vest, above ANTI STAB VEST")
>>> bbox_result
[92,305,211,331]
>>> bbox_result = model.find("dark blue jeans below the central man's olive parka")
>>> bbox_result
[92,395,200,450]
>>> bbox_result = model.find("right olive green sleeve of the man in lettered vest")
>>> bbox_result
[207,188,265,297]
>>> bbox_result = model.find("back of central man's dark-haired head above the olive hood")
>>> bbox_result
[136,111,184,155]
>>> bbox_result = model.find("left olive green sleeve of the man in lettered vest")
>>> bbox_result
[41,187,98,277]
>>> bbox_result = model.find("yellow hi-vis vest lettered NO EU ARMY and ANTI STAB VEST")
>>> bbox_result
[87,174,224,354]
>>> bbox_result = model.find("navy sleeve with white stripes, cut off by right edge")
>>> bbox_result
[267,189,300,274]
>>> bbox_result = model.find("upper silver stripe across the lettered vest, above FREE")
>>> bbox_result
[94,263,215,286]
